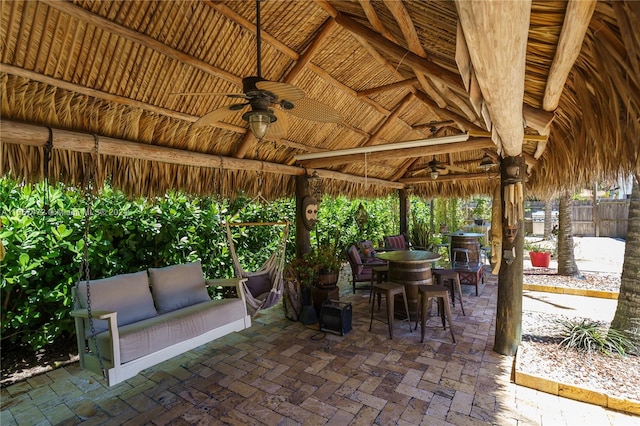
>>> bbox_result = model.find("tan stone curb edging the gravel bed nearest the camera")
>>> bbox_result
[515,370,640,415]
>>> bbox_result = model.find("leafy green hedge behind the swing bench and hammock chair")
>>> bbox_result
[0,176,480,350]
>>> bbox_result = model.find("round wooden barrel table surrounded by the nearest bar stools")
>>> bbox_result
[377,250,440,321]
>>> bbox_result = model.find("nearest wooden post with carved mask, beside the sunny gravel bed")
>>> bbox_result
[493,156,526,356]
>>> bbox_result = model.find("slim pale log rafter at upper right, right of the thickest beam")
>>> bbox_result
[542,0,596,111]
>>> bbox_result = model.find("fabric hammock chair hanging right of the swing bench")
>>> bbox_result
[225,222,289,316]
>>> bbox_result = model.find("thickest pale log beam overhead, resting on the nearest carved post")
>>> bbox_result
[456,0,531,156]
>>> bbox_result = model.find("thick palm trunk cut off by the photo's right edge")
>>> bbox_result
[611,176,640,353]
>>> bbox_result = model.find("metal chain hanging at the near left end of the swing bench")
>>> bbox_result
[78,135,107,378]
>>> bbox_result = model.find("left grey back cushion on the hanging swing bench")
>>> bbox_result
[78,271,158,336]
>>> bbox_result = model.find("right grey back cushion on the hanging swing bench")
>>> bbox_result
[149,260,211,314]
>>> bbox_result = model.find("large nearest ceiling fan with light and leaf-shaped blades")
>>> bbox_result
[193,0,342,139]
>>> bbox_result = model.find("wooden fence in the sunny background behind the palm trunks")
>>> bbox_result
[525,199,629,239]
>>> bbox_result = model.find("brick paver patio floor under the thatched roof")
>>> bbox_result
[0,266,640,426]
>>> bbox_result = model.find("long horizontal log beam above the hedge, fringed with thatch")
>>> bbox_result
[0,120,404,189]
